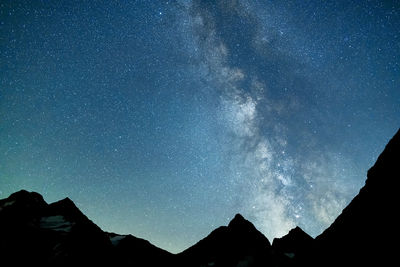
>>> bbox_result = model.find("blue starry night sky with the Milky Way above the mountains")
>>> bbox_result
[0,0,400,252]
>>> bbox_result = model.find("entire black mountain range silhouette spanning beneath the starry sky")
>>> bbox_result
[0,131,400,267]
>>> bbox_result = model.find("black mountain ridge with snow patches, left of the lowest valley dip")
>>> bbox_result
[0,190,172,266]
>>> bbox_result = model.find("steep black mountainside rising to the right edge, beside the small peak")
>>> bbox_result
[315,130,400,266]
